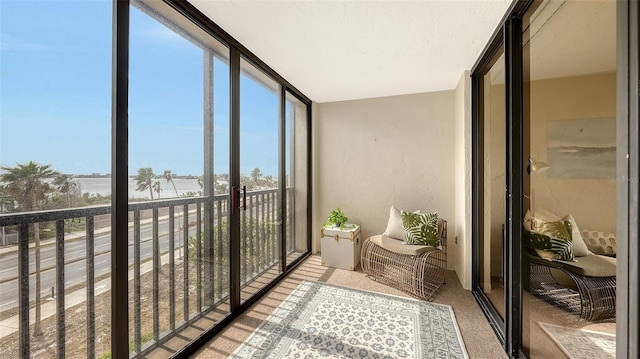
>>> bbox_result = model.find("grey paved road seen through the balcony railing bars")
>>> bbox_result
[0,221,189,312]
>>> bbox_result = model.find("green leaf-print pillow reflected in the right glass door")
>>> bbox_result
[529,219,575,261]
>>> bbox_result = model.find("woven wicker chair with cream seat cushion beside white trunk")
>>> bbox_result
[361,219,447,300]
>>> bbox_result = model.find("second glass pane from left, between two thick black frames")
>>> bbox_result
[128,1,232,356]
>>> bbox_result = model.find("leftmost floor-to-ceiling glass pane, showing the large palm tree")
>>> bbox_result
[0,1,112,358]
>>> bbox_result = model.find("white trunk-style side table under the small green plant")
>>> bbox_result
[320,223,362,270]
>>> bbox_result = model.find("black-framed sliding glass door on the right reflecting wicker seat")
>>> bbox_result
[471,0,640,358]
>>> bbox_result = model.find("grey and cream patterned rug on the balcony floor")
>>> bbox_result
[232,281,468,359]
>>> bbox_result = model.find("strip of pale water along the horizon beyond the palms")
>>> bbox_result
[73,177,202,199]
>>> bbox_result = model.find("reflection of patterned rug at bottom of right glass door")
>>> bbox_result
[538,322,616,359]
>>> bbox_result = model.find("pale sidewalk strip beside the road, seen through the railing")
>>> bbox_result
[0,249,179,339]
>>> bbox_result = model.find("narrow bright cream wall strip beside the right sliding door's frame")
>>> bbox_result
[449,71,472,290]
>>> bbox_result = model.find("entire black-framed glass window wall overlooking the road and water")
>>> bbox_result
[0,0,310,358]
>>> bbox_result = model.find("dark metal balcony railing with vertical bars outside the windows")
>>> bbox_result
[0,189,295,358]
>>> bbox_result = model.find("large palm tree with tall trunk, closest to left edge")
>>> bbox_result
[0,161,60,335]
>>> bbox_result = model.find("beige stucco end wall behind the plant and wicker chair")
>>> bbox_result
[312,91,458,269]
